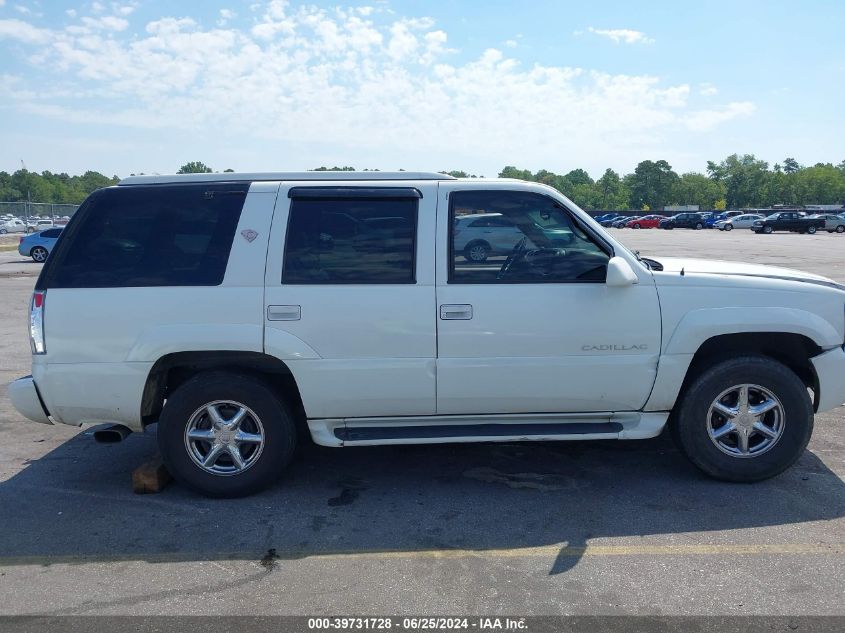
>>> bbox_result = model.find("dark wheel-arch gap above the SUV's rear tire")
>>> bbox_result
[141,351,307,433]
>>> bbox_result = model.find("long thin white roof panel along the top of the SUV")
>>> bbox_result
[118,171,457,185]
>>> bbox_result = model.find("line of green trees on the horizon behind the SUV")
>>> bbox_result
[0,154,845,211]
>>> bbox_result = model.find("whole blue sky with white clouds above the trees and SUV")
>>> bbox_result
[0,0,845,177]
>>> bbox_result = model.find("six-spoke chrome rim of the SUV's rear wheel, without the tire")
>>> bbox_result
[185,400,265,475]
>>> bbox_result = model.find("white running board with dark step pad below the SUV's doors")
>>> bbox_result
[308,412,669,446]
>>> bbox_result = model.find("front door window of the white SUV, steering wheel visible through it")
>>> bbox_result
[449,190,610,284]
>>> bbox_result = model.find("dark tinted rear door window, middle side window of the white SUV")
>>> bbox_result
[282,198,418,284]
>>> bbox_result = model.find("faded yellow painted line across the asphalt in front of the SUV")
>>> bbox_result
[0,543,845,567]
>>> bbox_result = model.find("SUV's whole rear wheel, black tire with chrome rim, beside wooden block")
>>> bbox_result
[158,371,296,497]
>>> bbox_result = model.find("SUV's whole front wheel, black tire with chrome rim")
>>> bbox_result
[674,356,813,482]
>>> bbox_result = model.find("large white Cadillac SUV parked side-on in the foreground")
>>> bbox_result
[9,172,845,496]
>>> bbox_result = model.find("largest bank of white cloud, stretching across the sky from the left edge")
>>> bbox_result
[0,0,754,173]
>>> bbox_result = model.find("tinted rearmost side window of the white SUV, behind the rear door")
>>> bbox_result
[38,183,249,289]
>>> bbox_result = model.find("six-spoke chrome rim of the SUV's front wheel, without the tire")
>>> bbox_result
[707,384,786,458]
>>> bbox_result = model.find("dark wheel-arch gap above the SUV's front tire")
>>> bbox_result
[681,332,822,410]
